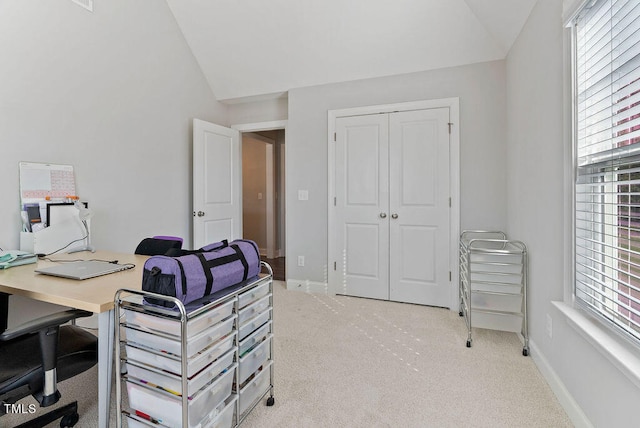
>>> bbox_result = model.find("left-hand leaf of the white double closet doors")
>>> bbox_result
[335,115,389,300]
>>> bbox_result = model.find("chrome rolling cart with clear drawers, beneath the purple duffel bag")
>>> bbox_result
[115,262,274,428]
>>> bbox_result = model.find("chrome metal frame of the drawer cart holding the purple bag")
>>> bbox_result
[114,261,275,428]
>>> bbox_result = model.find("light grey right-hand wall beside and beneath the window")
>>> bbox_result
[507,0,640,427]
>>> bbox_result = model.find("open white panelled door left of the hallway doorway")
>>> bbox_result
[193,119,242,248]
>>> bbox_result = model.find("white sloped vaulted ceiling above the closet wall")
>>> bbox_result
[167,0,537,101]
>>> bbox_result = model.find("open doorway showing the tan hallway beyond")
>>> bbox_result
[233,123,286,281]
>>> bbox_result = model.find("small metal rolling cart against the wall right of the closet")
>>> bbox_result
[459,230,529,356]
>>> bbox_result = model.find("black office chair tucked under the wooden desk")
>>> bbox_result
[0,293,98,428]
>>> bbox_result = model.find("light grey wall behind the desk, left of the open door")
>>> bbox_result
[0,0,227,251]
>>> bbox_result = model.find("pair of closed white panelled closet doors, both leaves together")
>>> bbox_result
[334,108,451,307]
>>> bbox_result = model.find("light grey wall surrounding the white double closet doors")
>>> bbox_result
[286,61,507,283]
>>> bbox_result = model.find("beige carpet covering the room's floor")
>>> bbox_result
[0,282,572,428]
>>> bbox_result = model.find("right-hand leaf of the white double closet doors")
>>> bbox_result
[389,108,451,307]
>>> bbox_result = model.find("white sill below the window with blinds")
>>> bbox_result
[551,302,640,388]
